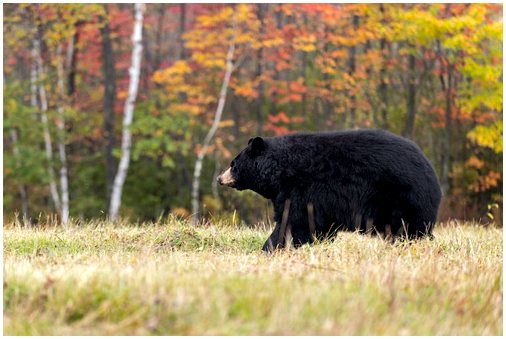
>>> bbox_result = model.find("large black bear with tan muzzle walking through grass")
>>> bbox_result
[217,129,441,251]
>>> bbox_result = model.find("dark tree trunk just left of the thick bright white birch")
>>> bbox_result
[100,5,116,201]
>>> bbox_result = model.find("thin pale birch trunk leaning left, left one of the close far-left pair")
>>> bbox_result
[32,39,61,213]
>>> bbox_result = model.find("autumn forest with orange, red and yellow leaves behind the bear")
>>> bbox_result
[3,3,503,225]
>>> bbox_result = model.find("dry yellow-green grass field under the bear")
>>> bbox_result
[3,221,503,335]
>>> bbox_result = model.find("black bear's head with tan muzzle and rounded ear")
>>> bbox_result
[216,137,280,199]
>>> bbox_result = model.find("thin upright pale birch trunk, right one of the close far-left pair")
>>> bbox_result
[56,45,69,227]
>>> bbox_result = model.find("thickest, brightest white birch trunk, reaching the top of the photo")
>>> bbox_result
[109,4,145,220]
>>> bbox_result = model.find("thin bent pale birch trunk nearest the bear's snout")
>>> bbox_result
[192,41,235,225]
